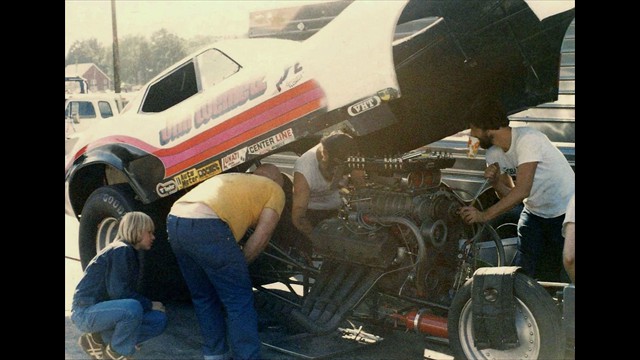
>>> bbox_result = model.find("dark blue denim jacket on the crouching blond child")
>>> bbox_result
[72,241,151,311]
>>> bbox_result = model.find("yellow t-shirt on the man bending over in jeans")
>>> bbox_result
[176,173,285,241]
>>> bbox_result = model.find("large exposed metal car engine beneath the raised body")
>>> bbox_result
[311,150,464,298]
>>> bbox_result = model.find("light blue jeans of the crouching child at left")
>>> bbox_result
[71,299,167,355]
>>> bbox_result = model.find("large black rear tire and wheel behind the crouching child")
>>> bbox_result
[79,184,189,301]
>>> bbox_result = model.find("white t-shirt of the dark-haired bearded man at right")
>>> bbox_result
[486,127,576,219]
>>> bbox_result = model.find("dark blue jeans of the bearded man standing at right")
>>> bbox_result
[514,208,570,282]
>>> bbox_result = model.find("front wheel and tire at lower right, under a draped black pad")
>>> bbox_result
[448,273,564,360]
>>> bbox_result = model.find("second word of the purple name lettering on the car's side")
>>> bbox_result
[193,78,267,129]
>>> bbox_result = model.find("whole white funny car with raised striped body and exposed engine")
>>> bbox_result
[65,0,575,358]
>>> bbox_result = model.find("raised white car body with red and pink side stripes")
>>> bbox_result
[65,0,575,300]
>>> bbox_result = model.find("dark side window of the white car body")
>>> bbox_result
[142,62,198,113]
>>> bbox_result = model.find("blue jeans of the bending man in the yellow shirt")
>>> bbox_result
[167,214,261,360]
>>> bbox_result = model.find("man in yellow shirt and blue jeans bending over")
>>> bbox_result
[167,164,285,360]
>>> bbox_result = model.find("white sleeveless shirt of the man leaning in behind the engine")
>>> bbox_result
[293,144,342,210]
